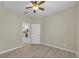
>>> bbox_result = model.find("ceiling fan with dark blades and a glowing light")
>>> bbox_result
[25,1,45,13]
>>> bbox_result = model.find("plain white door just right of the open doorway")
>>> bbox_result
[31,24,40,44]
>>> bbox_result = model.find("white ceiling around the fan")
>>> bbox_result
[0,1,77,17]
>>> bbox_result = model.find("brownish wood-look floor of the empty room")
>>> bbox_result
[0,44,76,58]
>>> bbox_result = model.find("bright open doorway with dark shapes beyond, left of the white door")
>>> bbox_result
[22,22,30,44]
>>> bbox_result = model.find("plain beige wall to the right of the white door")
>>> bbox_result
[42,8,77,51]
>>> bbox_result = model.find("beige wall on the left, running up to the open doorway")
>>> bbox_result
[0,5,29,52]
